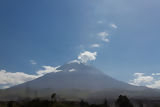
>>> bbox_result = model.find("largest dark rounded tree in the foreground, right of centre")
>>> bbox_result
[116,95,133,107]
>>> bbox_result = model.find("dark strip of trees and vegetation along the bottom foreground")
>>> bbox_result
[0,93,160,107]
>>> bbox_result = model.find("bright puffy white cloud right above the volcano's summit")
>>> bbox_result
[78,51,97,63]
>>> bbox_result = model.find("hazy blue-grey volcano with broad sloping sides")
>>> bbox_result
[0,62,160,100]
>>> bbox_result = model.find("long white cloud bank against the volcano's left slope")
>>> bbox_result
[0,66,61,88]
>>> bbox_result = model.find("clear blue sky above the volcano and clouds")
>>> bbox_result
[0,0,160,88]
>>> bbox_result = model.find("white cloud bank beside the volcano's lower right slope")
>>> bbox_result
[129,73,160,88]
